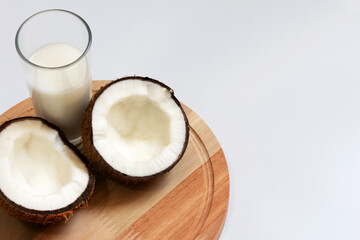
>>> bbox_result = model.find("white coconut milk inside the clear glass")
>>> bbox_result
[28,43,91,140]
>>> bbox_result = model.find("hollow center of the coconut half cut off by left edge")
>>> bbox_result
[9,133,72,195]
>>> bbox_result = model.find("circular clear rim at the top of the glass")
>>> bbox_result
[15,9,92,69]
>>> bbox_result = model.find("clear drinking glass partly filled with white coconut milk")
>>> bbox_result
[15,9,92,144]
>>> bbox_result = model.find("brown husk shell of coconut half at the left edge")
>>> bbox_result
[0,116,95,225]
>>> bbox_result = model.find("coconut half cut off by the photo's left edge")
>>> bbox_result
[0,117,95,224]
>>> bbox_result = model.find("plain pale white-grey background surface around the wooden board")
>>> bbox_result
[0,0,360,240]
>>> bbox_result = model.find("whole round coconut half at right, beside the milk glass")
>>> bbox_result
[82,77,189,182]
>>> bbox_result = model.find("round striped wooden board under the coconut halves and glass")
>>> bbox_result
[0,81,229,240]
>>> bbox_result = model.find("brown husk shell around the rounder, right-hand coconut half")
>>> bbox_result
[81,76,189,183]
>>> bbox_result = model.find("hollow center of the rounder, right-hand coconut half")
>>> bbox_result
[106,96,170,161]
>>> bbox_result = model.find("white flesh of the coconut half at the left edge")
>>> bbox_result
[0,120,89,211]
